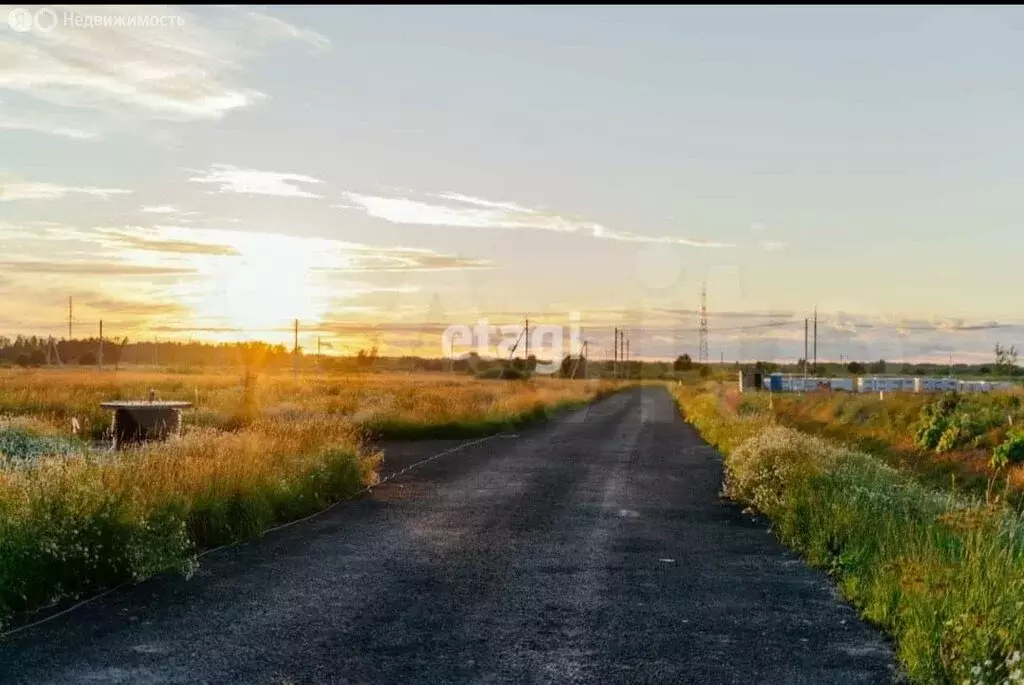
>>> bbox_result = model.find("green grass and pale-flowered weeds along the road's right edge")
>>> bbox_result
[676,384,1024,685]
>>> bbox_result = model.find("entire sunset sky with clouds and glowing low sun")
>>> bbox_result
[0,5,1024,361]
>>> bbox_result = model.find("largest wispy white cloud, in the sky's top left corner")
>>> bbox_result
[0,5,330,121]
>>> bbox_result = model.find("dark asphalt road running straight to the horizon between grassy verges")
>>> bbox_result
[0,388,895,685]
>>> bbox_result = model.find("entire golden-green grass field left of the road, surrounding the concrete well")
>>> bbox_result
[0,370,616,625]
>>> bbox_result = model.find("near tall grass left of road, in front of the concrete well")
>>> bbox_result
[0,417,379,624]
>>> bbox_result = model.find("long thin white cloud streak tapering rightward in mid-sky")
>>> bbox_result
[333,191,732,248]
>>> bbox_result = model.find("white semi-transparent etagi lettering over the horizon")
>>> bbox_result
[441,311,581,375]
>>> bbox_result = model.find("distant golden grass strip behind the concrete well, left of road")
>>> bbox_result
[0,370,618,439]
